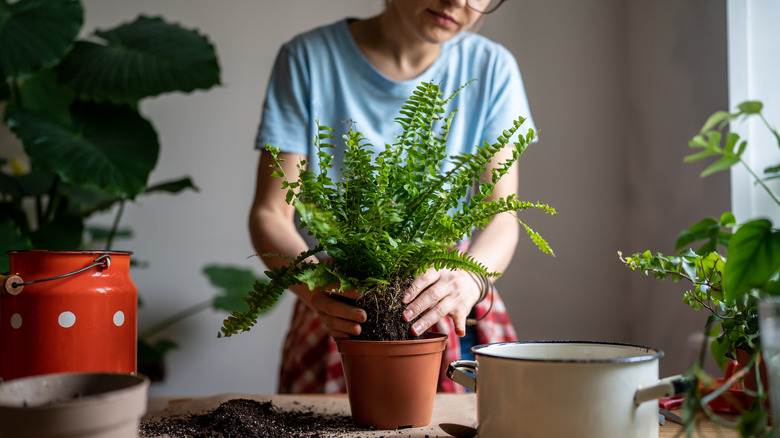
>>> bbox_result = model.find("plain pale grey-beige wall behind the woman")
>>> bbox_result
[1,0,728,395]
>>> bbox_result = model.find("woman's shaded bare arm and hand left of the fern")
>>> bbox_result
[249,150,366,338]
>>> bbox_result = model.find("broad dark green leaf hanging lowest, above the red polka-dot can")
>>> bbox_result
[8,104,160,199]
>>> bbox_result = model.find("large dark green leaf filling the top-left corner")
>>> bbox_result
[0,0,84,79]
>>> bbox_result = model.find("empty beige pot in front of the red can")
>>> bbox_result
[0,373,149,438]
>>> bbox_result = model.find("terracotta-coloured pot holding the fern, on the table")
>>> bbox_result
[336,334,447,429]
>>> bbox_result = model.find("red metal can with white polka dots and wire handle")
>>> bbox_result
[0,250,138,381]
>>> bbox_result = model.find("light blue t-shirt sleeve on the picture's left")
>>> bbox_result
[255,43,312,155]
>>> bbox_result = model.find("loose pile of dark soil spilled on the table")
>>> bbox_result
[139,399,373,438]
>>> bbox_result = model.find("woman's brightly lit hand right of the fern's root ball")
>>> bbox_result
[403,267,482,336]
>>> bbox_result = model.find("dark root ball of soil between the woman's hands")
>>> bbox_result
[352,277,419,341]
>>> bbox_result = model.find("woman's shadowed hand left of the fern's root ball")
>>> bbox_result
[295,286,368,339]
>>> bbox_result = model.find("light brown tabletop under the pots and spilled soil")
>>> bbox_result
[147,393,739,438]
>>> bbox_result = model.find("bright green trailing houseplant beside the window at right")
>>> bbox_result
[621,101,780,436]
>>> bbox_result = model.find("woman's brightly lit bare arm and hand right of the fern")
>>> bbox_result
[404,147,520,336]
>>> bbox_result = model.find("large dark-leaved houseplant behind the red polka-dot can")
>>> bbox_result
[0,0,220,378]
